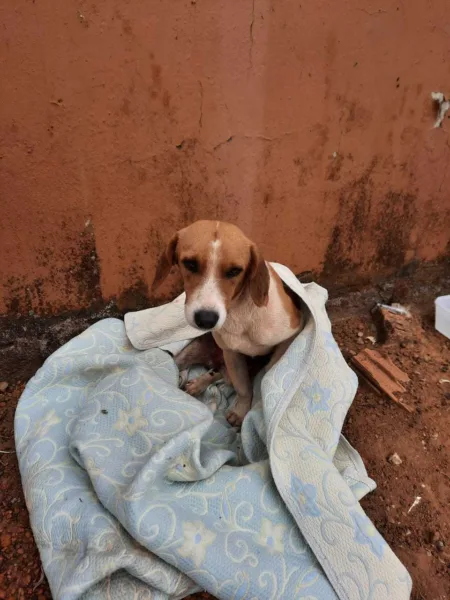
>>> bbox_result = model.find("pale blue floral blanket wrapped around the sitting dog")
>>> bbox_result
[15,265,411,600]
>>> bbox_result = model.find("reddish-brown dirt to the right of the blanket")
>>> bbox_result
[334,316,450,600]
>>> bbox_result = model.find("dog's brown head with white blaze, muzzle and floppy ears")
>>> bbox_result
[152,221,270,330]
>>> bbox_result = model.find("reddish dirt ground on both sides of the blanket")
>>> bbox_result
[0,309,450,600]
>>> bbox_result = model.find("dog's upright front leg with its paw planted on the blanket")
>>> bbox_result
[223,350,252,427]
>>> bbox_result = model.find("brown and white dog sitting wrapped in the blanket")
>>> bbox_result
[152,221,303,427]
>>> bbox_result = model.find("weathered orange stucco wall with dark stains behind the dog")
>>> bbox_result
[0,0,450,314]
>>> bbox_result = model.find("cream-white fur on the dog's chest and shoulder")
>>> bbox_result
[213,273,301,356]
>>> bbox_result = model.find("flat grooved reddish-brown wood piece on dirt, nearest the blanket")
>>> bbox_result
[351,348,414,413]
